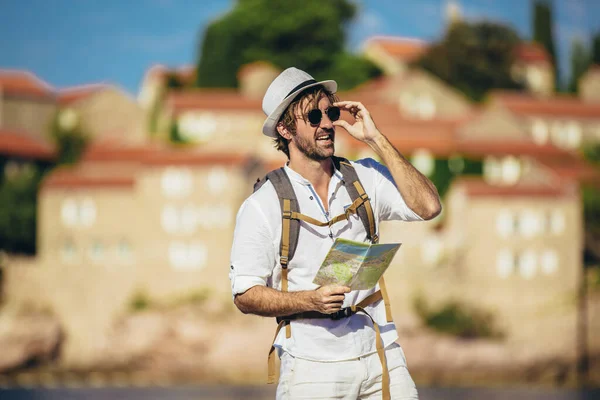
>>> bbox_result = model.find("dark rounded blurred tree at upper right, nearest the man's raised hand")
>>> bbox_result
[415,22,523,101]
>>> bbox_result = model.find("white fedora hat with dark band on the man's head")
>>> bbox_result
[263,67,337,138]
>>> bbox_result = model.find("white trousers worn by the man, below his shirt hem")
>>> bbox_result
[277,343,419,400]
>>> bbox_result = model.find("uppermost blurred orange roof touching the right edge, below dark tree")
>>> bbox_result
[488,90,600,119]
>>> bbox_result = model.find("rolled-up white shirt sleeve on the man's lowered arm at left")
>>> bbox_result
[229,197,276,297]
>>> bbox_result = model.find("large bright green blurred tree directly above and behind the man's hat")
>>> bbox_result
[197,0,380,89]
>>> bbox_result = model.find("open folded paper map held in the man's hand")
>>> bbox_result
[313,238,401,290]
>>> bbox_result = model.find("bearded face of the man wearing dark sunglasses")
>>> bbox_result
[290,96,335,161]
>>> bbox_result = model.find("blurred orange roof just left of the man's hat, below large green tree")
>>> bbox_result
[167,89,262,114]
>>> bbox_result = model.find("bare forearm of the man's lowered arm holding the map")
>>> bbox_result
[234,286,314,317]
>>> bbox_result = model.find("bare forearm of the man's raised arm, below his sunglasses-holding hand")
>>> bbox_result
[367,134,442,220]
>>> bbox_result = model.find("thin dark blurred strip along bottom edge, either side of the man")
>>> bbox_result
[0,386,600,400]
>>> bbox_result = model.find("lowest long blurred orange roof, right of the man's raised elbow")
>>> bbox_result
[452,177,574,198]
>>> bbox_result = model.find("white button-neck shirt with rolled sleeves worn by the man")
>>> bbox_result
[229,159,422,361]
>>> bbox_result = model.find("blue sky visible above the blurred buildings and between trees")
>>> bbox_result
[0,0,600,93]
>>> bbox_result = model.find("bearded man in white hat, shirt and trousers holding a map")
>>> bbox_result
[230,68,441,399]
